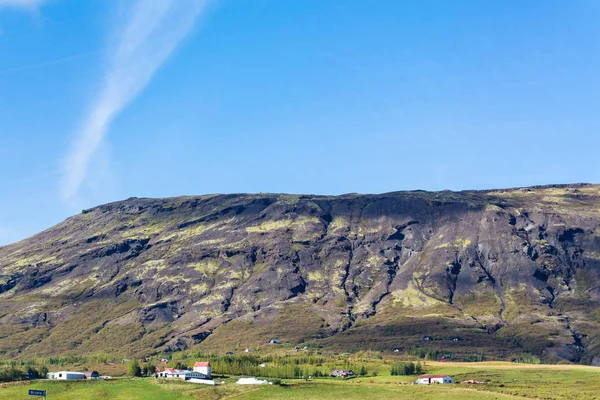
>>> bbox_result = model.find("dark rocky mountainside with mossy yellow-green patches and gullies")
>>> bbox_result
[0,185,600,363]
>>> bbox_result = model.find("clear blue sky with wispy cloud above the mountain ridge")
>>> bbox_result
[0,0,600,245]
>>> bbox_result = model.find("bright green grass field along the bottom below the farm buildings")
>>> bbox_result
[0,362,600,400]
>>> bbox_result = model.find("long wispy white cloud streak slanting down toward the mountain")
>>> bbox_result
[61,0,206,203]
